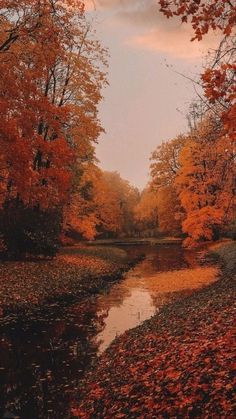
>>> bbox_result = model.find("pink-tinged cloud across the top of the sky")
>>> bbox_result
[85,0,219,60]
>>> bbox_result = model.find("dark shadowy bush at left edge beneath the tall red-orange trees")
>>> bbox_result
[0,200,62,259]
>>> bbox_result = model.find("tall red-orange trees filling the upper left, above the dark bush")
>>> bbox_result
[0,0,106,254]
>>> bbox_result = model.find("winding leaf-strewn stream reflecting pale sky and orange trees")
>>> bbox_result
[0,245,217,419]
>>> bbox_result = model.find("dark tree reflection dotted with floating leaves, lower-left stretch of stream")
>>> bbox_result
[0,299,107,419]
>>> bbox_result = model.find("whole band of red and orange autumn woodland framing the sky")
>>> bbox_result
[0,0,236,257]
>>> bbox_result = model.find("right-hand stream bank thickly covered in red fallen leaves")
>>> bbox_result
[72,243,236,419]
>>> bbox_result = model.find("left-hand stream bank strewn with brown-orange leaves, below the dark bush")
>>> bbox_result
[0,245,140,324]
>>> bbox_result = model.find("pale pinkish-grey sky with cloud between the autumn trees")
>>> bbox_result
[86,0,217,189]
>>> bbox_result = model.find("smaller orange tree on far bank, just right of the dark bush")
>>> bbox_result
[64,167,122,240]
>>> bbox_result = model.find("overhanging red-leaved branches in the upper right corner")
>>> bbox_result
[159,0,236,140]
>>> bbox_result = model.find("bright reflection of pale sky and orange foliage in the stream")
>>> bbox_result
[94,246,217,353]
